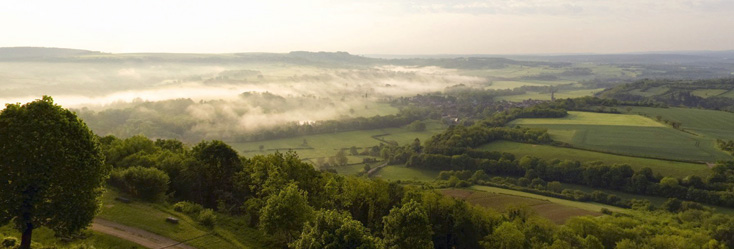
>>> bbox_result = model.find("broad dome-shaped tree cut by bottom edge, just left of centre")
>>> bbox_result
[290,210,379,249]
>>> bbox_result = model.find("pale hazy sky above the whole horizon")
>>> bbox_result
[0,0,734,54]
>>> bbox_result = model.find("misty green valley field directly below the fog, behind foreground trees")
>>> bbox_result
[229,121,446,164]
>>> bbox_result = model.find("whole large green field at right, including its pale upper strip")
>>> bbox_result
[509,112,731,162]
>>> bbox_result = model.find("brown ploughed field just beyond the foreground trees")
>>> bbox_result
[441,186,623,224]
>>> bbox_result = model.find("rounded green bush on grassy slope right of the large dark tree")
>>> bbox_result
[109,166,169,201]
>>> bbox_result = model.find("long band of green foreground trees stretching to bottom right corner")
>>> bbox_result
[100,136,734,249]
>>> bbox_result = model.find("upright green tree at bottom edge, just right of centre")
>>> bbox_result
[382,200,433,249]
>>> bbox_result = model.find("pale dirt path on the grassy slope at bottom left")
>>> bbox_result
[92,218,196,249]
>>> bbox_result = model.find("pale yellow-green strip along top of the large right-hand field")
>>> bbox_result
[509,111,665,127]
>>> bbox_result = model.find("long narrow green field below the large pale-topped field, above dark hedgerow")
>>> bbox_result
[479,141,711,177]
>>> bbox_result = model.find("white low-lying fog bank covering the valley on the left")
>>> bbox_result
[0,62,486,139]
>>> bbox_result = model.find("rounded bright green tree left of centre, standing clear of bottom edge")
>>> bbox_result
[260,183,313,242]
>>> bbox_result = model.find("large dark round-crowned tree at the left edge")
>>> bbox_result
[0,96,110,248]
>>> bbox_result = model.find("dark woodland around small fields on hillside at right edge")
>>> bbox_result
[598,78,734,111]
